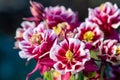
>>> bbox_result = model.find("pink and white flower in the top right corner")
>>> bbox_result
[86,2,120,40]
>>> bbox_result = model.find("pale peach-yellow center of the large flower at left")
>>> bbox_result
[30,33,42,44]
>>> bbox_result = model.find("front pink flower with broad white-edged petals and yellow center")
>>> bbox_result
[50,38,90,74]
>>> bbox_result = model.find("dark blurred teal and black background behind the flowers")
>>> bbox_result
[0,0,120,80]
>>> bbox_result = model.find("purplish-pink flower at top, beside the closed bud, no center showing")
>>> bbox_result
[44,6,79,30]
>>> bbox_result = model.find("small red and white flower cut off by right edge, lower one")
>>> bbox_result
[100,39,120,61]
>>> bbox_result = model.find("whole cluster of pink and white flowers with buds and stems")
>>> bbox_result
[15,1,120,80]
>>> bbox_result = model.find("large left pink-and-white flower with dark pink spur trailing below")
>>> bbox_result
[19,22,57,80]
